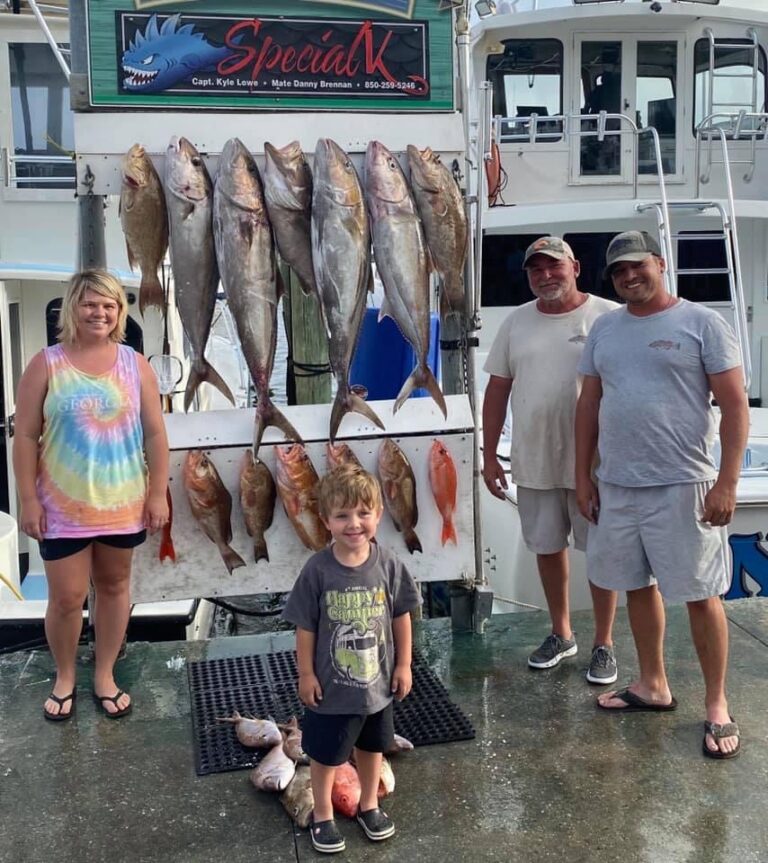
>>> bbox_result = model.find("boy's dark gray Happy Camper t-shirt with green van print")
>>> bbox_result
[283,543,421,716]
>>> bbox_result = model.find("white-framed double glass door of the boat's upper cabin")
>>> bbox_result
[571,33,690,185]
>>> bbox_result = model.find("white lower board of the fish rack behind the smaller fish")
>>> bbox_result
[132,395,475,602]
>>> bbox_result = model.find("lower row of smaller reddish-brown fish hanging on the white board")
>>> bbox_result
[177,438,458,574]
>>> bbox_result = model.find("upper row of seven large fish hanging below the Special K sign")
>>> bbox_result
[120,137,468,446]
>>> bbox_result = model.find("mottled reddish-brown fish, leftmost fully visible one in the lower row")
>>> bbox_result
[184,449,245,574]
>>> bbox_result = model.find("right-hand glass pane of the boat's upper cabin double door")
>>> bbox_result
[635,42,677,175]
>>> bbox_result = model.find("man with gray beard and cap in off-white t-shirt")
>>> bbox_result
[483,237,618,684]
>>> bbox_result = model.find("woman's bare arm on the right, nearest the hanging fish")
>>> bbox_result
[136,354,168,532]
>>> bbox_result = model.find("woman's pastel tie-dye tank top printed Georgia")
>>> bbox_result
[37,345,147,539]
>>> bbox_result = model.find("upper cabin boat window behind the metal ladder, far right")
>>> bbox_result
[693,39,766,137]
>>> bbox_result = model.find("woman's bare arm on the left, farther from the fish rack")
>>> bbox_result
[13,352,48,539]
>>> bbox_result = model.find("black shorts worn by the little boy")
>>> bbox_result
[301,702,395,767]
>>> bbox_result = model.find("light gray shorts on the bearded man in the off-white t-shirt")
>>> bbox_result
[517,486,589,554]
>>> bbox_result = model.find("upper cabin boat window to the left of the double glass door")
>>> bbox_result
[486,39,563,142]
